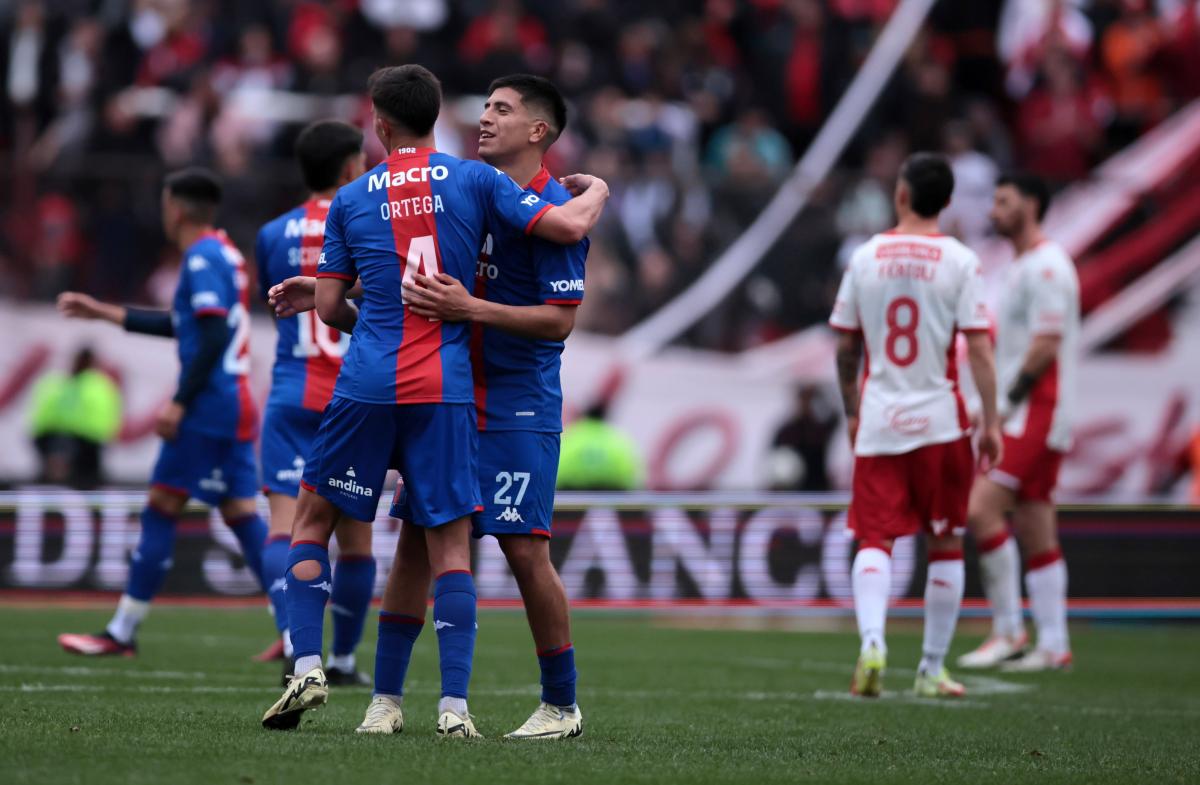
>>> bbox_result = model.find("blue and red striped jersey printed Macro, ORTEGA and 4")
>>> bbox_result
[317,148,552,403]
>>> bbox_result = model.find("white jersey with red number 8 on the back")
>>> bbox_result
[829,232,989,455]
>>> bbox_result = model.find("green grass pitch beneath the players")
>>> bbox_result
[0,607,1200,785]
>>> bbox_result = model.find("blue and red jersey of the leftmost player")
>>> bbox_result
[170,232,258,441]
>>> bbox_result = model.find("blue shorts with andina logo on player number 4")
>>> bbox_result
[300,396,479,527]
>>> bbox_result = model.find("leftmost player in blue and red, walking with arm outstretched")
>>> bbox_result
[59,168,266,657]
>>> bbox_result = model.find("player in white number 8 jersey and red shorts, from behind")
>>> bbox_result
[829,152,1001,697]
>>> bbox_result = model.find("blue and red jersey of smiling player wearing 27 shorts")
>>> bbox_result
[470,167,588,433]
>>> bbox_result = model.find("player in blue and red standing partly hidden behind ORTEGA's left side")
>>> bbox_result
[254,120,376,685]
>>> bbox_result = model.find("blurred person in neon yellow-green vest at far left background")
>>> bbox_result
[29,347,121,489]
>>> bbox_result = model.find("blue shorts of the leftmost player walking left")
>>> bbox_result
[150,431,258,504]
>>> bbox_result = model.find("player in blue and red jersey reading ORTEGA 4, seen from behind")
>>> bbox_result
[256,65,607,737]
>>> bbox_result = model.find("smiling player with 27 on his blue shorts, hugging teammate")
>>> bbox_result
[272,74,588,738]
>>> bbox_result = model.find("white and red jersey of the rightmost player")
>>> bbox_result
[996,240,1079,451]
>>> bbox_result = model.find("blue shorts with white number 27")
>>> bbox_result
[391,431,559,537]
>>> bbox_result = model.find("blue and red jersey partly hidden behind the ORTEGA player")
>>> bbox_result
[254,198,350,412]
